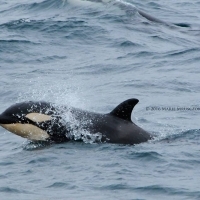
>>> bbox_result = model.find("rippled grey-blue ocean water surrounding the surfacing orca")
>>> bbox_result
[0,0,200,200]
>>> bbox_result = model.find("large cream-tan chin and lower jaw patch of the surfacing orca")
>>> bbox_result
[0,123,50,141]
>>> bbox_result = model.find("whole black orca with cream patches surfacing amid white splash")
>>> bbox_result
[0,99,151,144]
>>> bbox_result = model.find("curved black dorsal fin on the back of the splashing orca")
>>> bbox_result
[110,99,139,121]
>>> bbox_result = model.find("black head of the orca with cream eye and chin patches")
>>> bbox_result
[0,101,67,142]
